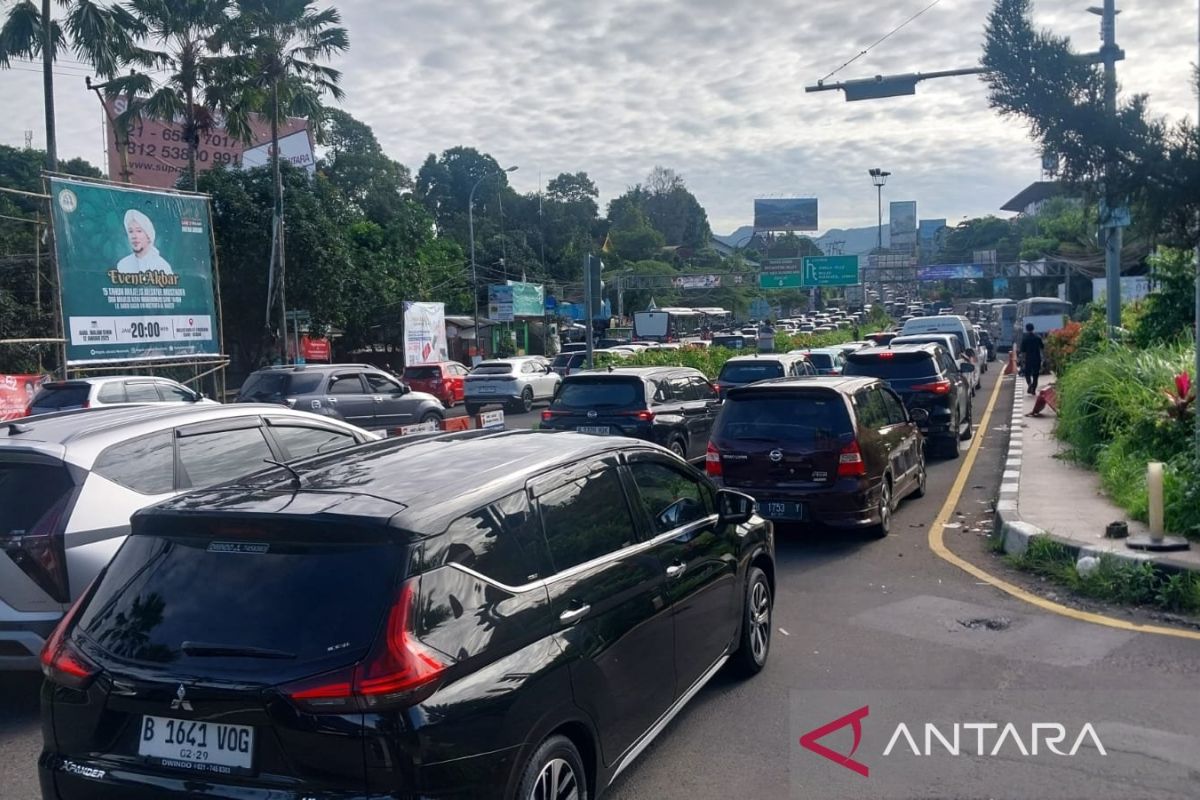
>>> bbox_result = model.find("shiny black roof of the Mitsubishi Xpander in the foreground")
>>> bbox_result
[143,431,665,535]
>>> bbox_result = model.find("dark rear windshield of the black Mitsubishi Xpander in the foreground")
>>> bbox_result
[79,525,403,670]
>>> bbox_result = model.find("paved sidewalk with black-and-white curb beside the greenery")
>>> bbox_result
[996,377,1200,572]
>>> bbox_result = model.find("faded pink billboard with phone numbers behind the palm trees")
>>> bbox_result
[104,98,312,188]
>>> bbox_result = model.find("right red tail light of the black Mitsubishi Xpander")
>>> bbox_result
[283,578,446,714]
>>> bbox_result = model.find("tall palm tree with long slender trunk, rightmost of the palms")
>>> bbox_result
[217,0,350,359]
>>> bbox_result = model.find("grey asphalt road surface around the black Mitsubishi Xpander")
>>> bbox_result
[9,365,1200,800]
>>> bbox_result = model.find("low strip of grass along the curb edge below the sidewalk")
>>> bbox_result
[1006,536,1200,614]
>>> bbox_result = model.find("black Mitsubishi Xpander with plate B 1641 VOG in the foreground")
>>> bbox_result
[40,431,775,800]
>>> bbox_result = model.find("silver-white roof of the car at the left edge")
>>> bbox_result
[0,403,355,468]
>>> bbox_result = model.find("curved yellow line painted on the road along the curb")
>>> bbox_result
[929,375,1200,640]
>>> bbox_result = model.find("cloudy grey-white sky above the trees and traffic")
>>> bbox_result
[0,0,1198,233]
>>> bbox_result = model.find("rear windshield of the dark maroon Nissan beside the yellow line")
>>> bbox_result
[714,390,853,450]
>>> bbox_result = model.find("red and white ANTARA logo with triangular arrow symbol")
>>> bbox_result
[800,705,1109,777]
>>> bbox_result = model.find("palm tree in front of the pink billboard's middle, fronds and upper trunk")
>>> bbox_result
[104,0,233,190]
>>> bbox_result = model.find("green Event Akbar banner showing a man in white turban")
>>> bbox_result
[50,178,220,365]
